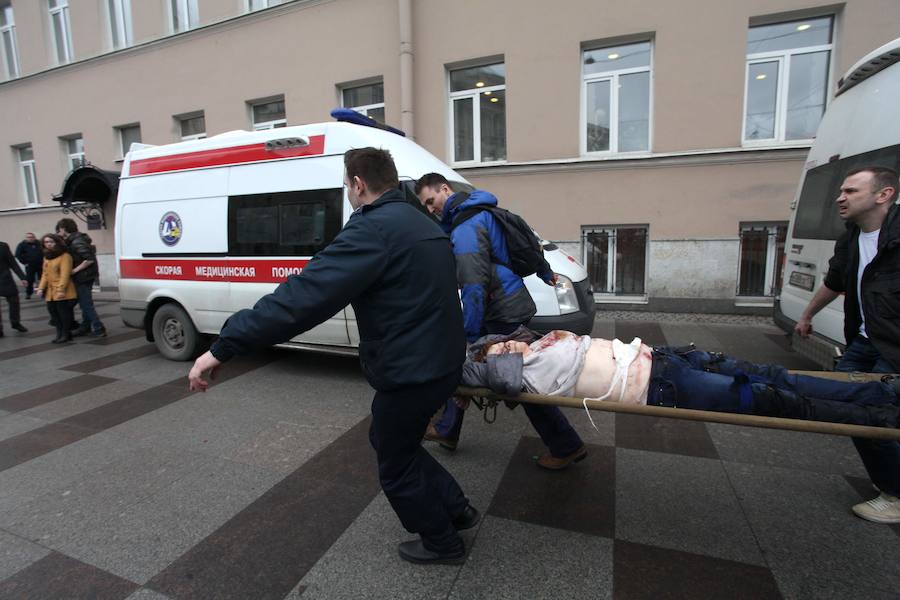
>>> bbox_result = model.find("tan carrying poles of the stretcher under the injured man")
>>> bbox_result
[456,371,900,441]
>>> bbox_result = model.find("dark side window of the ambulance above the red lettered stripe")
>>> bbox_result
[228,188,342,256]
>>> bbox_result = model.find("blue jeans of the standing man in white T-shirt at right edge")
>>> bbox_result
[835,335,900,496]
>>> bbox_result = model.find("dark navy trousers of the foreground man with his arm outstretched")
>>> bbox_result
[369,369,468,551]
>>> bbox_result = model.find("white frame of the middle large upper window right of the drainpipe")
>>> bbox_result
[579,40,654,156]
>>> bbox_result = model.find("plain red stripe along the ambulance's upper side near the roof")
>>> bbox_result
[129,135,325,175]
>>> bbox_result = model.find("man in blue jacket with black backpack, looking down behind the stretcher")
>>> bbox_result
[416,173,587,470]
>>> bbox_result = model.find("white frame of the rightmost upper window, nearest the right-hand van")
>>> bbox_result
[741,23,837,148]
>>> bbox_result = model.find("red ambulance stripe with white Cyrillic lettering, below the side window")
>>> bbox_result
[119,258,309,283]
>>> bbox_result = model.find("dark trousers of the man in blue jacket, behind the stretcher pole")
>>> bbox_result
[434,321,584,458]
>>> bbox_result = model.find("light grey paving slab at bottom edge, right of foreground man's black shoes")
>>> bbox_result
[448,517,613,600]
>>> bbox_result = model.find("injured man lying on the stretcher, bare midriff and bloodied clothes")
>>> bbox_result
[462,327,900,428]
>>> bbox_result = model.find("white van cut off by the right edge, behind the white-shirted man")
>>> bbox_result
[775,38,900,369]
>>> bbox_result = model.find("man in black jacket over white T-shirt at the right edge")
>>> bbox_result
[795,167,900,523]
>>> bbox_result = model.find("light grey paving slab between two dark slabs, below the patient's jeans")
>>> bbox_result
[616,448,765,565]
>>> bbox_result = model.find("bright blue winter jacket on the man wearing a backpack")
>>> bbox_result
[441,190,537,342]
